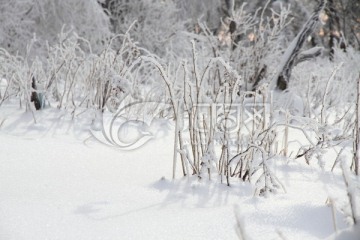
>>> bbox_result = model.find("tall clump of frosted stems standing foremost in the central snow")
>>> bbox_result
[143,25,286,194]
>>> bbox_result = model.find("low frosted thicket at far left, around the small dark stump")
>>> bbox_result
[0,27,150,119]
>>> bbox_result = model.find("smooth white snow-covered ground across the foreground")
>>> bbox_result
[0,105,360,240]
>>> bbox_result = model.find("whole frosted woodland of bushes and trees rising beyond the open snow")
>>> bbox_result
[0,0,360,239]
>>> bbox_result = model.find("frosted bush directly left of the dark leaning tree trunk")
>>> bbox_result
[230,2,291,90]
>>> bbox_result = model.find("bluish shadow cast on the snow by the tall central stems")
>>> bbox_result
[72,176,253,221]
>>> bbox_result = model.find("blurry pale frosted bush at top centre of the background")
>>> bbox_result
[105,0,186,56]
